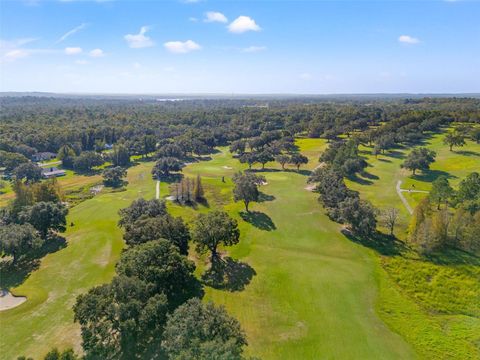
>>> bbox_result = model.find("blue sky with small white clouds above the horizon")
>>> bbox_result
[0,0,480,94]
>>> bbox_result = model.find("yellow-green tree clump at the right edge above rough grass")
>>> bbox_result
[409,172,480,254]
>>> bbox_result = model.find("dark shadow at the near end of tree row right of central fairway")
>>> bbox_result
[342,229,407,256]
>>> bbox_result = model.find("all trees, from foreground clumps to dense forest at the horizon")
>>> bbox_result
[0,97,480,359]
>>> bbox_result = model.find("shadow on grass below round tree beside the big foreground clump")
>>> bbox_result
[202,256,257,292]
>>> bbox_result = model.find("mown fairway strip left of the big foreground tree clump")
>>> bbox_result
[0,163,155,359]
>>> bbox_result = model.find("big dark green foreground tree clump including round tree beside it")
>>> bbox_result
[69,199,247,360]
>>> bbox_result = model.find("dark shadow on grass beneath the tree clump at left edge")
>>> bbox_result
[0,234,67,289]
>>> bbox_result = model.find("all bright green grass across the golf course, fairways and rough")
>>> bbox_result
[0,135,480,359]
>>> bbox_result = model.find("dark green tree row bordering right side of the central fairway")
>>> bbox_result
[309,165,377,237]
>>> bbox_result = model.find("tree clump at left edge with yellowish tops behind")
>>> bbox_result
[0,179,67,265]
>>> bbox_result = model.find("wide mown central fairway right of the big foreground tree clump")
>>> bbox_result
[170,139,414,359]
